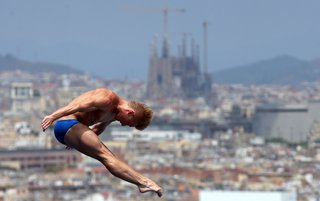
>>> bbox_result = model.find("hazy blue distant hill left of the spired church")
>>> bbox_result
[0,55,82,74]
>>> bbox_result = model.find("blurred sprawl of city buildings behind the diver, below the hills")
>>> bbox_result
[0,60,320,201]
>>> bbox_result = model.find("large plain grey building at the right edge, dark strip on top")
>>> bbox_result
[253,102,320,143]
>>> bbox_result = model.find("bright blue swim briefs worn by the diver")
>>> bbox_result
[54,119,79,144]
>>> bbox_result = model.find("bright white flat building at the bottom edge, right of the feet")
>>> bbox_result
[199,191,297,201]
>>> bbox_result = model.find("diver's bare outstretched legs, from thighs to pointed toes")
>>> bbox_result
[64,123,162,196]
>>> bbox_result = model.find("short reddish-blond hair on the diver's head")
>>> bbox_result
[129,101,153,130]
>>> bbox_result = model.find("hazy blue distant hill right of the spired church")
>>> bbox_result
[213,56,320,84]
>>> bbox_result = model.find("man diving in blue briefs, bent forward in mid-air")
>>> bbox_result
[41,88,162,197]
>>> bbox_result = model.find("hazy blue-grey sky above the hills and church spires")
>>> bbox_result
[0,0,320,79]
